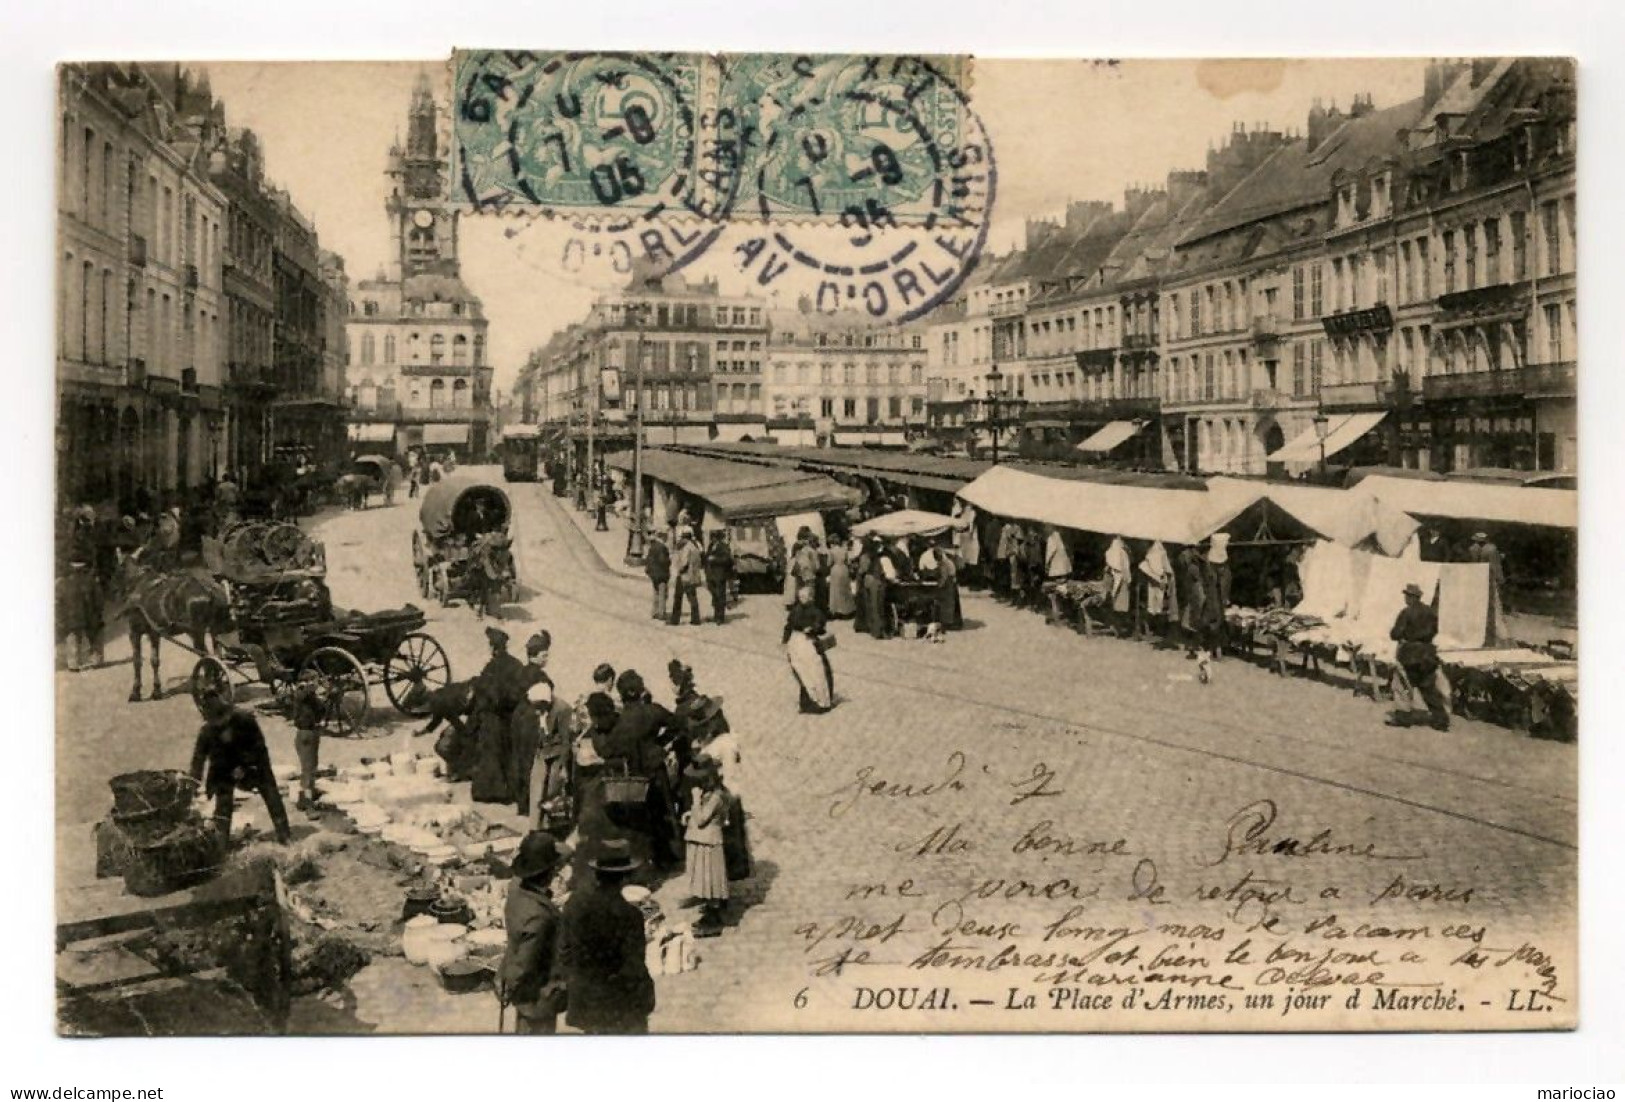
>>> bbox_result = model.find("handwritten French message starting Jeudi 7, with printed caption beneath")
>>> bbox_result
[793,751,1575,1030]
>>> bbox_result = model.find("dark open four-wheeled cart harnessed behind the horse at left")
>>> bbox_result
[171,528,452,735]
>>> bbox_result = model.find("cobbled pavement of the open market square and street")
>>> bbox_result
[57,471,1578,1032]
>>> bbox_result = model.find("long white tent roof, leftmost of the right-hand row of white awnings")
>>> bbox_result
[959,466,1235,543]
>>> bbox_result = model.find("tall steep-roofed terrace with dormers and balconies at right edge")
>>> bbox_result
[1164,59,1575,473]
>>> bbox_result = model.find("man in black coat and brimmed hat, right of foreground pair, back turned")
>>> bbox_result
[559,840,655,1034]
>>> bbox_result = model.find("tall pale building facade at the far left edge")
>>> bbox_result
[57,65,226,504]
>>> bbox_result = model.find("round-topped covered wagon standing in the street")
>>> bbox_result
[411,478,517,611]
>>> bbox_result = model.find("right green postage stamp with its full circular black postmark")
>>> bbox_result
[723,55,998,322]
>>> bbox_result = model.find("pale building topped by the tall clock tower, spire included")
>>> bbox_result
[346,78,492,457]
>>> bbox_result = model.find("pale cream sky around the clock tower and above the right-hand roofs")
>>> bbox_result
[205,59,1427,390]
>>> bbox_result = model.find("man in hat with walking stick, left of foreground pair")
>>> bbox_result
[497,831,569,1034]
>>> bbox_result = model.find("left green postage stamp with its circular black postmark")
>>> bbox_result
[452,50,739,276]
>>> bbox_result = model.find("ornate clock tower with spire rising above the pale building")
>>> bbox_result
[385,73,458,280]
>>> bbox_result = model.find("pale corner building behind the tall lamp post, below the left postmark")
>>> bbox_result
[520,275,767,442]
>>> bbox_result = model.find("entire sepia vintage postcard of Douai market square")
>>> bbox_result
[55,54,1581,1035]
